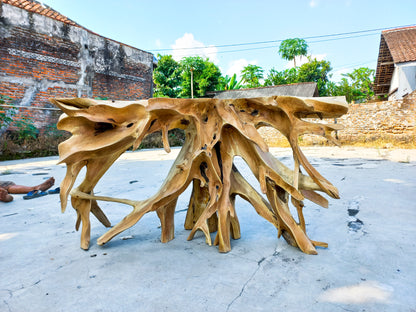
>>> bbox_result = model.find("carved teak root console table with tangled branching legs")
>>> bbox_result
[51,96,347,254]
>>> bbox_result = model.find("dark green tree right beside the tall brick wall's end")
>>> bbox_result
[153,54,181,98]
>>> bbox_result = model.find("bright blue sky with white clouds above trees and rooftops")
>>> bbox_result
[41,0,416,81]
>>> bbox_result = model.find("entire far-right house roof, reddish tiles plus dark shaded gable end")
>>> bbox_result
[374,26,416,95]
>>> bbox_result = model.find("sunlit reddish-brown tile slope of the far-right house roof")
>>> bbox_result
[382,26,416,63]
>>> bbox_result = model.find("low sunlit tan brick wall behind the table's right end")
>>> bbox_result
[259,91,416,144]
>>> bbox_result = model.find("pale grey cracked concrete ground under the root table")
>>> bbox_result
[0,147,416,312]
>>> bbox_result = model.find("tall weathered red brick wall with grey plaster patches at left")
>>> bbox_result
[0,2,153,132]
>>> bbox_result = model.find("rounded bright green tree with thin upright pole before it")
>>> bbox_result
[179,56,221,97]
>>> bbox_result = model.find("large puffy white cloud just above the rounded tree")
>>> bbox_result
[172,33,218,64]
